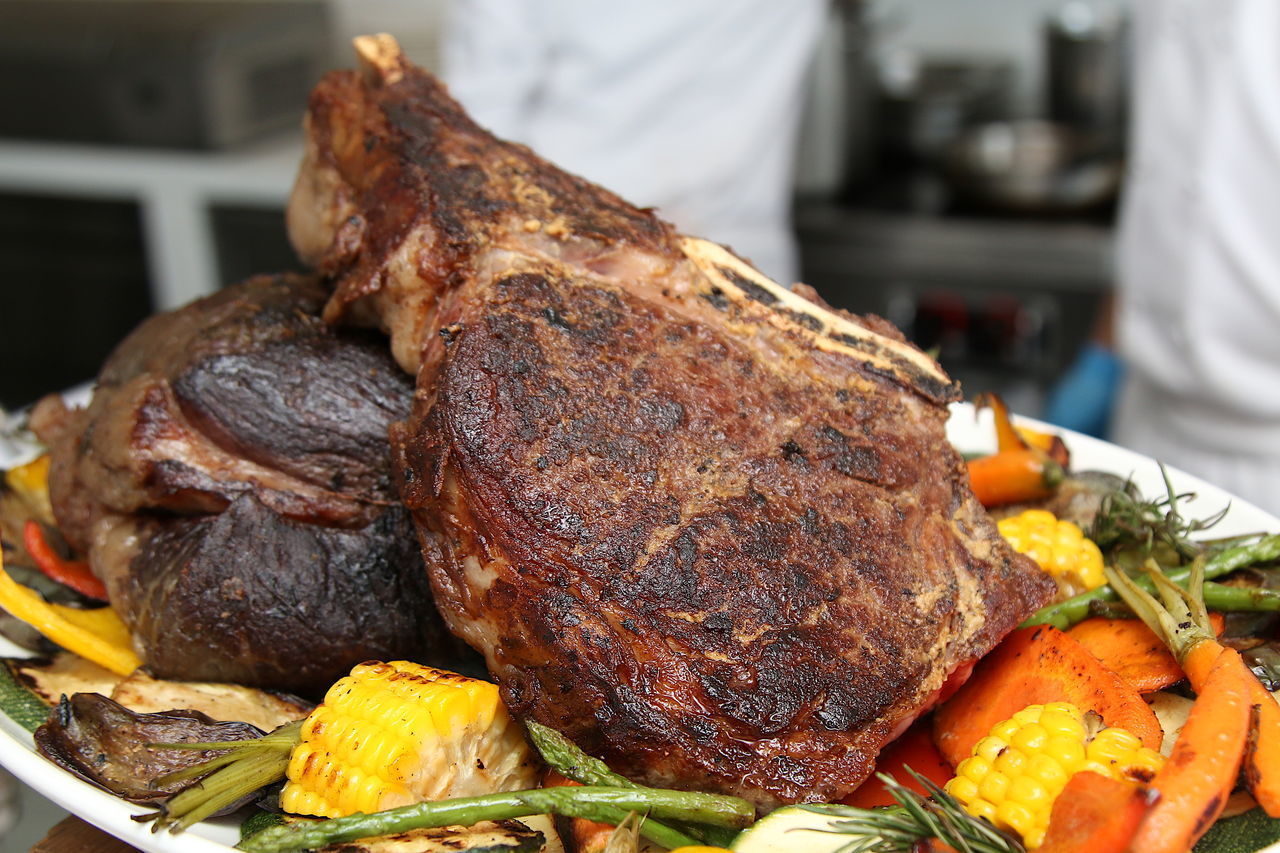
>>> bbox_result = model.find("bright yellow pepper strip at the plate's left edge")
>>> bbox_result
[0,548,142,675]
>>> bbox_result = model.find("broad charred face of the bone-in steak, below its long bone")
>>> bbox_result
[393,262,1047,800]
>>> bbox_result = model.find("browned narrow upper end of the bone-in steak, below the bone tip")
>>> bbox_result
[298,69,676,306]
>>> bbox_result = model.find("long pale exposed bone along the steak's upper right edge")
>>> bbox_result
[680,237,956,402]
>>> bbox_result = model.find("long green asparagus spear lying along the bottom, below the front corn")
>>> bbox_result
[238,786,755,853]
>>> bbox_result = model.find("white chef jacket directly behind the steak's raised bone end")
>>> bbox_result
[444,0,826,283]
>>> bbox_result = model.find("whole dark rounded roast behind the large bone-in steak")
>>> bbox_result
[33,277,453,694]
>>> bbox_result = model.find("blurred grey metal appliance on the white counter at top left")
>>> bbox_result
[0,0,330,149]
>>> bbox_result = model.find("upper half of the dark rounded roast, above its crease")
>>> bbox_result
[49,275,412,549]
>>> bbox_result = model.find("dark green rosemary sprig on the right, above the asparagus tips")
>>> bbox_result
[1089,465,1230,562]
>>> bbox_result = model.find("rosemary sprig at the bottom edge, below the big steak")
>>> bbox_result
[801,767,1027,853]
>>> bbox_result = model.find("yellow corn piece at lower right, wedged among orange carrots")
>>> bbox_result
[945,702,1164,848]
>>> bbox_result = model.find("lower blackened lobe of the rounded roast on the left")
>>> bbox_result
[115,494,452,697]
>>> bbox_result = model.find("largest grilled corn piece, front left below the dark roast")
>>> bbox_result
[280,661,538,817]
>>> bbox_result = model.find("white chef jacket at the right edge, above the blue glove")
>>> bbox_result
[1112,0,1280,515]
